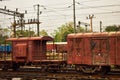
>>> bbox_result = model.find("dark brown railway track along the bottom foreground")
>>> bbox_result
[0,69,120,80]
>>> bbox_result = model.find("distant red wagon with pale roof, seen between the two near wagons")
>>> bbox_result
[47,42,67,60]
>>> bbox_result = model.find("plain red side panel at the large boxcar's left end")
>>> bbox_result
[67,38,84,64]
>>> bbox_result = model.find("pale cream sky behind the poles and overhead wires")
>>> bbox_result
[0,0,120,33]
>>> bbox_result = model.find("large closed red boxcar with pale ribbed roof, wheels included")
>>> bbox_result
[67,32,120,72]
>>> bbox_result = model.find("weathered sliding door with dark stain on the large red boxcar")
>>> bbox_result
[90,38,109,65]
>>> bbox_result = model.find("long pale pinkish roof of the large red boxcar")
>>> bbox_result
[68,32,120,38]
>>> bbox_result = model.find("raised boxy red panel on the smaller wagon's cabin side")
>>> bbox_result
[12,41,27,62]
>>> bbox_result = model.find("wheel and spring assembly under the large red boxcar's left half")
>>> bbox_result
[80,66,98,73]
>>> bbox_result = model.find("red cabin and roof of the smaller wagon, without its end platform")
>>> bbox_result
[4,36,53,69]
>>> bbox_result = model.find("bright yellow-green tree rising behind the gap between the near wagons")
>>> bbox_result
[52,22,84,42]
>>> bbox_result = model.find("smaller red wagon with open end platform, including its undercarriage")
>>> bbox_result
[1,36,65,70]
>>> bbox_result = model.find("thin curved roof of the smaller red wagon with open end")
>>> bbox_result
[6,36,53,41]
